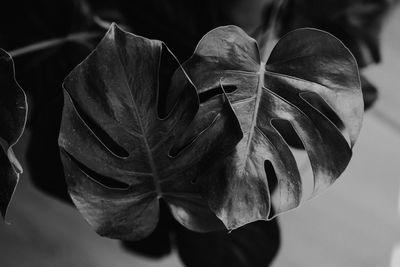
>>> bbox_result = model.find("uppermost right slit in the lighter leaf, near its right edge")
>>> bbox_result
[300,92,350,147]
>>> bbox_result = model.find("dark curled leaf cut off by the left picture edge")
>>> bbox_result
[0,49,27,217]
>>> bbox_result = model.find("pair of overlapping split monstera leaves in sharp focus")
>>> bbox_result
[59,22,363,240]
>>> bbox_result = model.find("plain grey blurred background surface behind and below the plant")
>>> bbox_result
[0,0,400,267]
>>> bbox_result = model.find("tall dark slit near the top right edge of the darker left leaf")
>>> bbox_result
[157,43,180,118]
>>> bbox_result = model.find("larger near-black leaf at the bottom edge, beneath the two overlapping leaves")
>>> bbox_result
[175,220,280,267]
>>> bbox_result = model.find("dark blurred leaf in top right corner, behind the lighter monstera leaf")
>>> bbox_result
[265,0,398,110]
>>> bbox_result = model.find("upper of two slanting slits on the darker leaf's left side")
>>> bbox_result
[71,93,129,158]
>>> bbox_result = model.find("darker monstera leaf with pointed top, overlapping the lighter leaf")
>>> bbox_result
[59,24,242,240]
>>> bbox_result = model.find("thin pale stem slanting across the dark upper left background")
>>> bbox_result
[9,32,102,58]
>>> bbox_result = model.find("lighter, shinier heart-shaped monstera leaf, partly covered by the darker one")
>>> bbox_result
[183,26,363,229]
